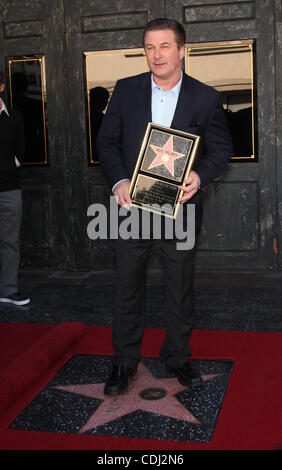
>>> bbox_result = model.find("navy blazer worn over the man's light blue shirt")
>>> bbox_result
[97,72,233,228]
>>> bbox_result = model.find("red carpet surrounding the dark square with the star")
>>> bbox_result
[0,323,282,451]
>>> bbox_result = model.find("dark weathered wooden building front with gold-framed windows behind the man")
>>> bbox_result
[0,0,282,272]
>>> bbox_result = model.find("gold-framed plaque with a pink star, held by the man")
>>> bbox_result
[129,122,200,219]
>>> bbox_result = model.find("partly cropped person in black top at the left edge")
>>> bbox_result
[0,71,30,305]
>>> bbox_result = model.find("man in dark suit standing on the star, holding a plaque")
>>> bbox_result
[98,19,232,395]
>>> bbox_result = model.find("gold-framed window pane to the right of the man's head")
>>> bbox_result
[185,40,257,161]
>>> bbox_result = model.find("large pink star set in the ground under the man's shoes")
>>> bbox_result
[55,363,219,433]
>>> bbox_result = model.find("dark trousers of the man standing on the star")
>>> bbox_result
[113,239,194,367]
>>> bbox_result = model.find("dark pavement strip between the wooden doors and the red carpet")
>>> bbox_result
[0,269,282,332]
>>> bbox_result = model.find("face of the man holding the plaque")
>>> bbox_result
[144,29,184,85]
